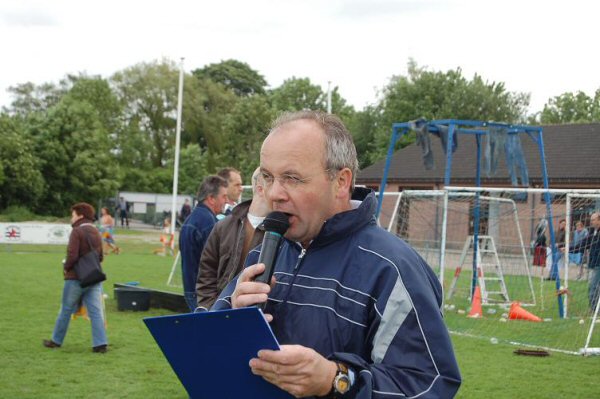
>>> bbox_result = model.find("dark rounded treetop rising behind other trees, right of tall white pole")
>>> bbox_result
[192,60,267,97]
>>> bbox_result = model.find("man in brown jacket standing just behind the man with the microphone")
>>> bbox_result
[196,168,271,310]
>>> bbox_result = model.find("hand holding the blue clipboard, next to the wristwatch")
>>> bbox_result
[250,345,337,398]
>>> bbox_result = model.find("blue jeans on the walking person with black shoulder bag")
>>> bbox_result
[52,280,108,346]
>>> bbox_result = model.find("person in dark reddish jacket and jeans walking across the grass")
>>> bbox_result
[42,202,108,353]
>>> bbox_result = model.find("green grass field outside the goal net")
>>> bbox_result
[0,231,600,399]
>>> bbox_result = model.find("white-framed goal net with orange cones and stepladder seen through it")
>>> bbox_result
[379,188,600,353]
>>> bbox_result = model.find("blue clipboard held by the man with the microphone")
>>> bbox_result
[144,307,292,399]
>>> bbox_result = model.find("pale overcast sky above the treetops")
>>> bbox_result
[0,0,600,112]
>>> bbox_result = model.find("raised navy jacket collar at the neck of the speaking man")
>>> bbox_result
[310,187,377,247]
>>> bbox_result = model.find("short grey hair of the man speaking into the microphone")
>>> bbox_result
[269,110,358,192]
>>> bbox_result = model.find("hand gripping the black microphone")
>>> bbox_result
[231,263,275,322]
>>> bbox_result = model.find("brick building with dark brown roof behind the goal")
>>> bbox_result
[356,123,600,244]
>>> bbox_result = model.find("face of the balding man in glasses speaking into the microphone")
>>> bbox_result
[260,120,335,246]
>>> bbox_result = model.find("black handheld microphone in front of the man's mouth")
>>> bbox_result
[254,211,290,309]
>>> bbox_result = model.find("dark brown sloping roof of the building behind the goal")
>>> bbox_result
[356,123,600,192]
